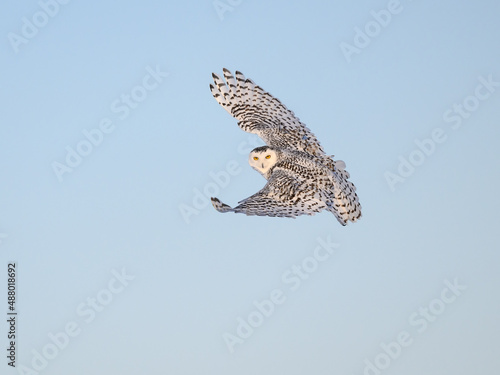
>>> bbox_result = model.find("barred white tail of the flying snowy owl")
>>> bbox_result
[327,160,361,225]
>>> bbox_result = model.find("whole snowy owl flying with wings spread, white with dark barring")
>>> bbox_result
[210,68,361,225]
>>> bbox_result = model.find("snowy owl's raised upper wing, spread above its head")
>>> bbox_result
[210,68,325,157]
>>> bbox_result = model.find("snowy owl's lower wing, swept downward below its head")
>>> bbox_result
[211,170,326,218]
